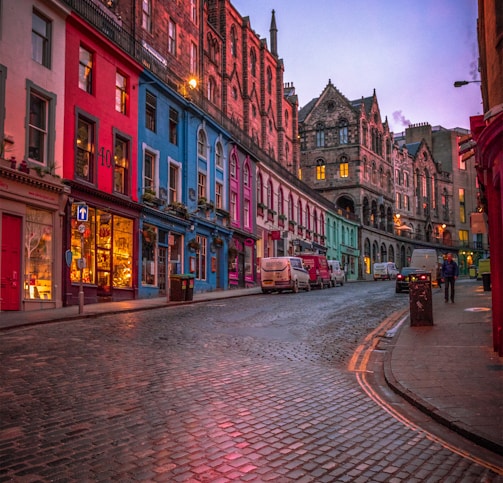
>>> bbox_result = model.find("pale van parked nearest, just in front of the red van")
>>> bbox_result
[260,257,311,293]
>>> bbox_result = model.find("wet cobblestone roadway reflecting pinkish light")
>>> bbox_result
[0,289,501,483]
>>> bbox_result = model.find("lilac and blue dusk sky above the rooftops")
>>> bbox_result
[231,0,483,133]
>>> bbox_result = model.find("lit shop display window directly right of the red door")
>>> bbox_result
[24,207,54,300]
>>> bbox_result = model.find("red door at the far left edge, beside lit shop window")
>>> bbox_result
[0,213,22,310]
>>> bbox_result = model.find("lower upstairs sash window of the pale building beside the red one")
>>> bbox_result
[28,91,49,164]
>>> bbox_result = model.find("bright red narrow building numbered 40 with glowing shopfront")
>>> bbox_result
[63,9,142,305]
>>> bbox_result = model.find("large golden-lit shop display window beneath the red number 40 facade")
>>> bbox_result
[70,205,134,296]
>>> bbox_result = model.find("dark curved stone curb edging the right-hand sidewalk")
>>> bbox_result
[383,327,503,455]
